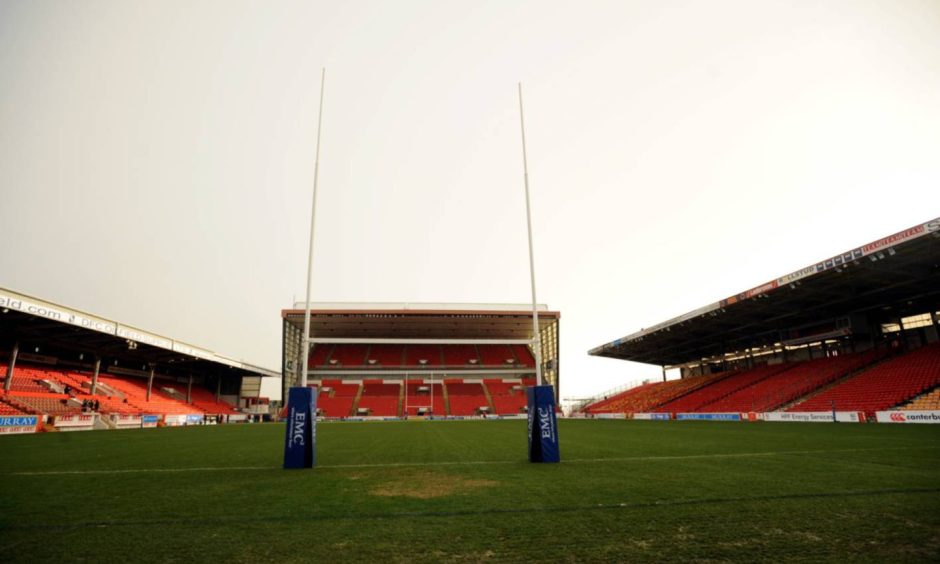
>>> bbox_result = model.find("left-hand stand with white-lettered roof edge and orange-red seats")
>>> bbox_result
[0,288,277,428]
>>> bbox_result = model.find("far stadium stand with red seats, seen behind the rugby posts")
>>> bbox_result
[281,303,560,417]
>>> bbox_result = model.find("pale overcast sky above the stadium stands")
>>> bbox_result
[0,0,940,398]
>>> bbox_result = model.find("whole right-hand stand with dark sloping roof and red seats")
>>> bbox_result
[588,218,940,416]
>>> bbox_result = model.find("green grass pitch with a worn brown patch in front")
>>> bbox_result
[0,420,940,562]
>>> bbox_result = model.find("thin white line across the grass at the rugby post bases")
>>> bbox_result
[8,446,940,476]
